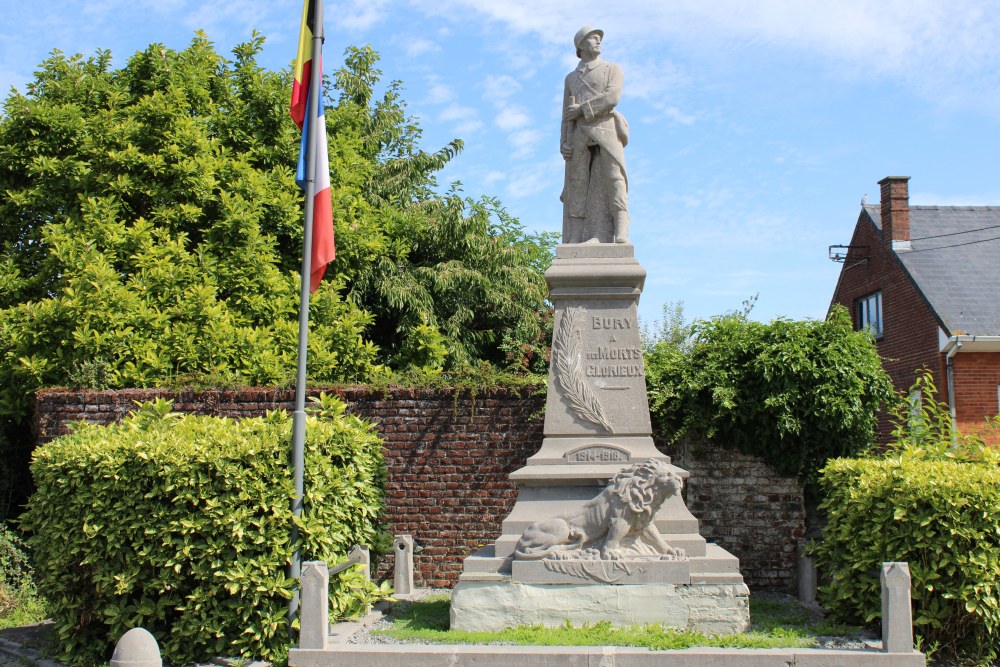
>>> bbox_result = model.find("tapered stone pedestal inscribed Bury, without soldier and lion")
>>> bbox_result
[451,243,749,632]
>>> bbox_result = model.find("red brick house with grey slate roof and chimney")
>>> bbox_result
[831,176,1000,439]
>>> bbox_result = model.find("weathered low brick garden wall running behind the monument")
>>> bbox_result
[35,387,804,590]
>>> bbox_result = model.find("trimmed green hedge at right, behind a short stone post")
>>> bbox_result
[816,456,1000,662]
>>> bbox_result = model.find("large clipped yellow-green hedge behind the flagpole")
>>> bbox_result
[23,397,386,665]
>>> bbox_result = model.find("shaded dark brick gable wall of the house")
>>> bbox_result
[833,212,948,442]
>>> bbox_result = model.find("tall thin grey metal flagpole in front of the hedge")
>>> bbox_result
[288,0,323,633]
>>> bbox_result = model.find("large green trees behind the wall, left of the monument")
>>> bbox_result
[0,33,553,516]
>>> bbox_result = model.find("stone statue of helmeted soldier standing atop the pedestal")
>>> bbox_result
[559,26,629,243]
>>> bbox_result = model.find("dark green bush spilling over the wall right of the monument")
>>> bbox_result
[646,308,893,485]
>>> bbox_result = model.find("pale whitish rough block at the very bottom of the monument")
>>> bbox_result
[451,578,750,634]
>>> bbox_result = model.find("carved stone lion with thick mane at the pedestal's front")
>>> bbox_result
[514,459,684,560]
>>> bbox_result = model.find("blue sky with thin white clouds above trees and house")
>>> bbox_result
[0,0,1000,322]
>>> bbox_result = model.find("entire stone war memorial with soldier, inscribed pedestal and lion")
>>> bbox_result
[451,27,750,633]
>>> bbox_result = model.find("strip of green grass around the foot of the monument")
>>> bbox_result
[377,595,857,650]
